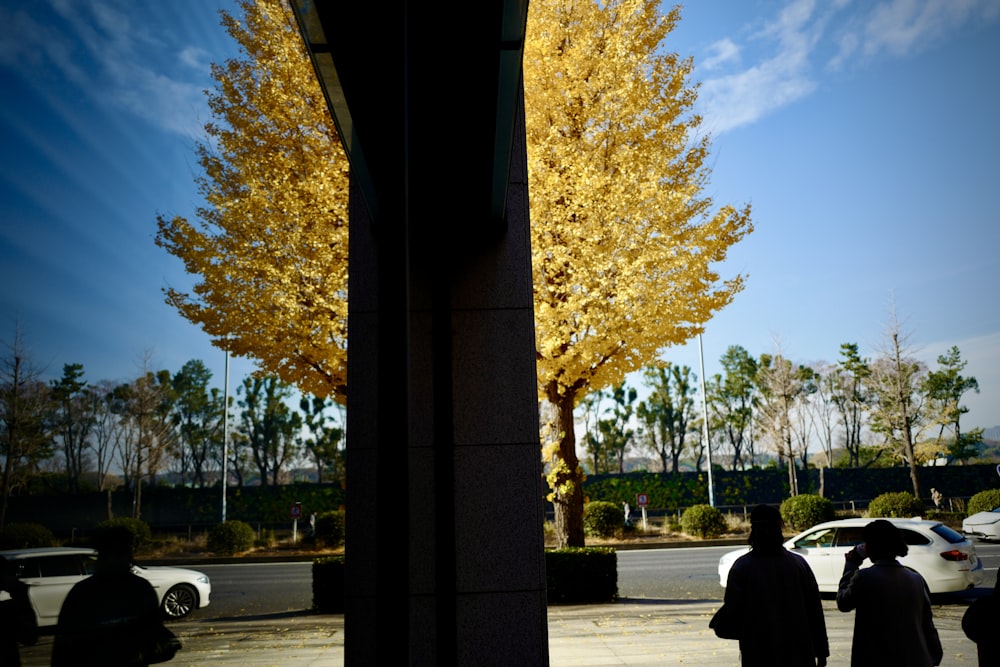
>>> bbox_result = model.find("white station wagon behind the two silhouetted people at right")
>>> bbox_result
[719,518,983,593]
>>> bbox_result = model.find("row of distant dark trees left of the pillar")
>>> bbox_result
[0,332,345,529]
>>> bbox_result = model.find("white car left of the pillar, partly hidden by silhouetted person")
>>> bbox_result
[0,547,212,627]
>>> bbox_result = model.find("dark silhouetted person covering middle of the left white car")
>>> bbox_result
[52,527,181,667]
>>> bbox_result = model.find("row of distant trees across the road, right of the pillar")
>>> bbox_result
[578,326,983,498]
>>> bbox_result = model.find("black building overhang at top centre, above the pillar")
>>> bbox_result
[291,0,528,240]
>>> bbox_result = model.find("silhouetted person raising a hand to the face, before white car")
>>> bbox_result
[837,519,943,667]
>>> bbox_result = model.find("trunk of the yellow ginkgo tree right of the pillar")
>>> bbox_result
[549,396,585,549]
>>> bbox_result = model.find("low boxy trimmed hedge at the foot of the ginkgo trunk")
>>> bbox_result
[545,547,618,604]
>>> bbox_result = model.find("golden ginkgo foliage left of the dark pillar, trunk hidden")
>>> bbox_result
[156,0,348,402]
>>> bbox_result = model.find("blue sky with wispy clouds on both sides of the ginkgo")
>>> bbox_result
[0,0,1000,428]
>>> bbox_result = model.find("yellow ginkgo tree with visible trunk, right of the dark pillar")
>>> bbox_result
[524,0,752,546]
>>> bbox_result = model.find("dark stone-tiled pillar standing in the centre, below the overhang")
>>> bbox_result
[345,87,548,667]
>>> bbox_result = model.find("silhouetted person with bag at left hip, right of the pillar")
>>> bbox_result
[723,505,830,667]
